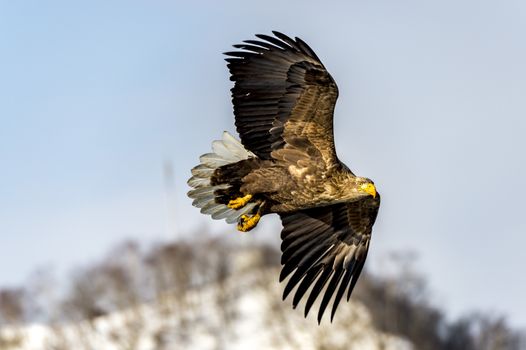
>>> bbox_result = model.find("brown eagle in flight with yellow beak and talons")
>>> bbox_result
[188,31,380,323]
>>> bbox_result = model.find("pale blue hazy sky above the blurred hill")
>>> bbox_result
[0,0,526,327]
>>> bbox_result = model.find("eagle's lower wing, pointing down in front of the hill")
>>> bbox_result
[280,195,380,322]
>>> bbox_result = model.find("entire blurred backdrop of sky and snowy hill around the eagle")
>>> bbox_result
[0,0,526,349]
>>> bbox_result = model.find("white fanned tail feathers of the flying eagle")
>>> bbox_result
[188,131,258,223]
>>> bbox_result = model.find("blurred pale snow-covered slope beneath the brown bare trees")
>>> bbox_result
[0,247,413,350]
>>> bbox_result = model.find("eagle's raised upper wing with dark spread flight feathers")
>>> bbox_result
[225,32,338,167]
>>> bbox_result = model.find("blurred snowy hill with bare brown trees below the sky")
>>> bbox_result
[0,233,526,350]
